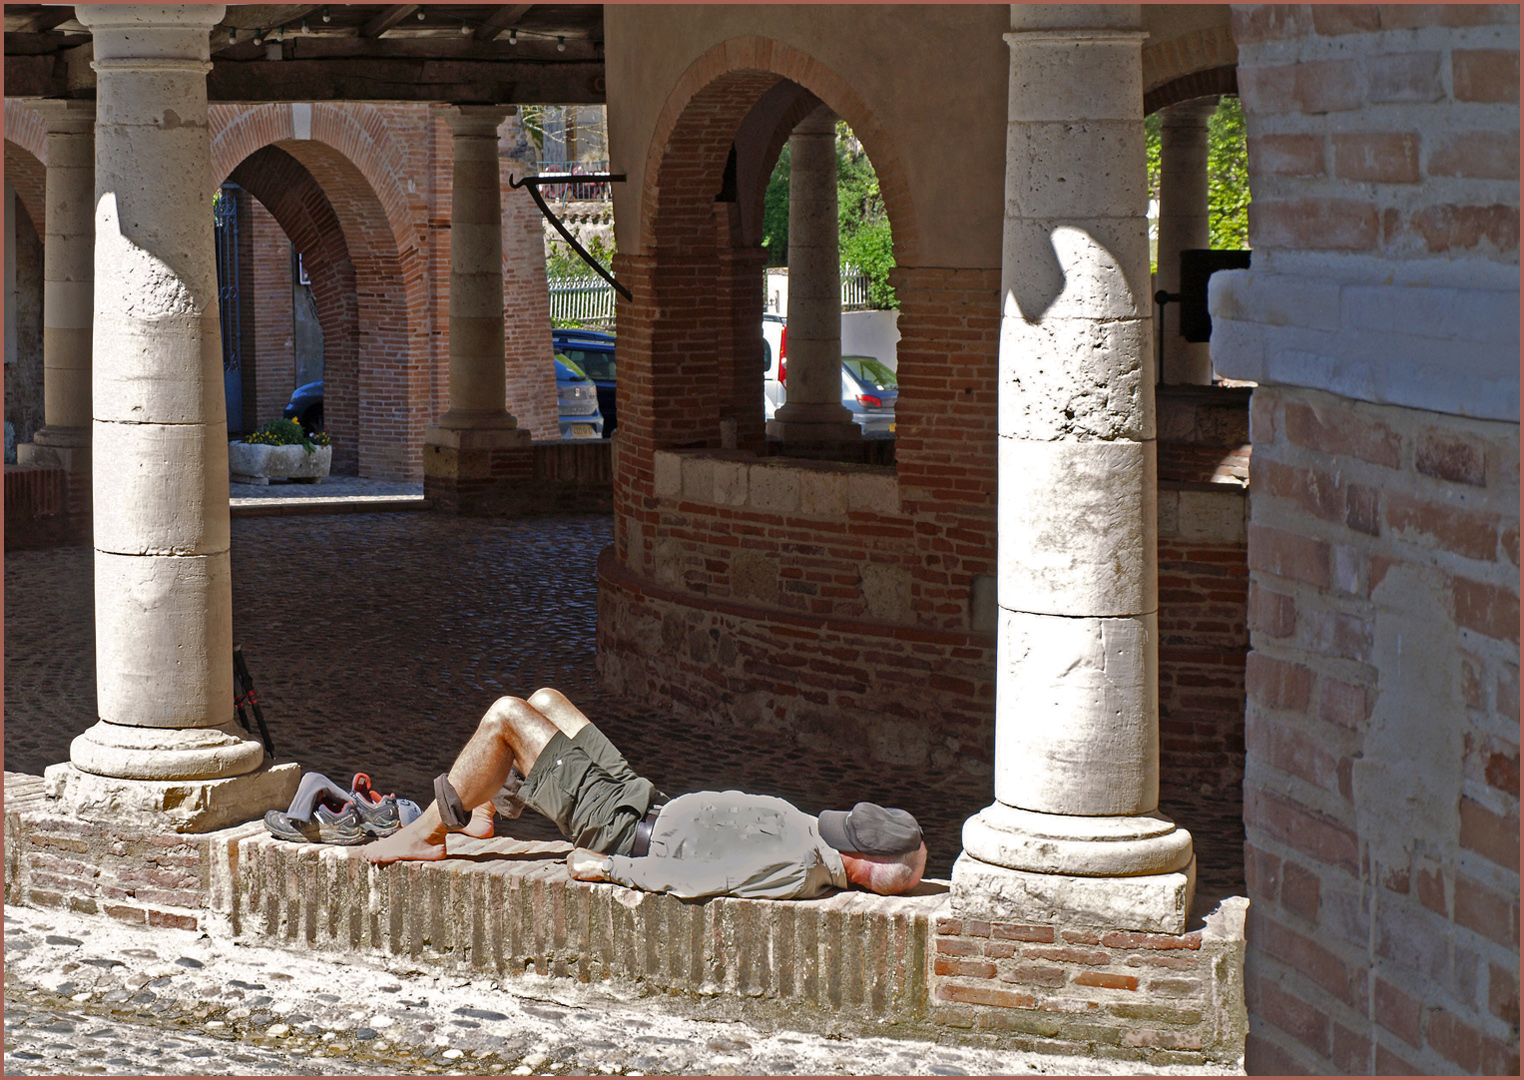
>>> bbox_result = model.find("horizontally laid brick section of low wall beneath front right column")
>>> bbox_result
[931,897,1248,1068]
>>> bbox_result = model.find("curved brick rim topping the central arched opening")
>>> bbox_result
[639,37,919,265]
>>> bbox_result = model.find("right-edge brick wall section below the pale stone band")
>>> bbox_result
[1245,388,1519,1072]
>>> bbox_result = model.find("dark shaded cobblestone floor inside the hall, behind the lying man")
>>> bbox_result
[5,511,1244,897]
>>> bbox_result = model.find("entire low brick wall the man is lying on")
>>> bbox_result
[5,772,1244,1071]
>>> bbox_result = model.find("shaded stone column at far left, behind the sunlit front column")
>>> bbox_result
[17,101,94,487]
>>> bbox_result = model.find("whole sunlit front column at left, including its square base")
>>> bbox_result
[47,5,300,832]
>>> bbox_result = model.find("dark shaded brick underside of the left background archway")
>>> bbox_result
[229,146,360,475]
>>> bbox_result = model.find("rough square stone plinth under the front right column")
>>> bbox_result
[953,852,1196,934]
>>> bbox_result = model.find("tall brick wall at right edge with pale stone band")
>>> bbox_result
[1212,5,1519,1074]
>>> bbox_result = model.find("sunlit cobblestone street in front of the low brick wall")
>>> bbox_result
[5,906,1215,1075]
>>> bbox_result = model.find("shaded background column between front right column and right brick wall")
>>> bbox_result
[1154,97,1218,385]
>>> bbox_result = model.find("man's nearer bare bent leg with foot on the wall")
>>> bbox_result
[361,698,560,862]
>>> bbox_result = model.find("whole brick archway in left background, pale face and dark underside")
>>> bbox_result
[212,105,434,480]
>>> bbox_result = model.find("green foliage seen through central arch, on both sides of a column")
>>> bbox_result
[762,122,899,308]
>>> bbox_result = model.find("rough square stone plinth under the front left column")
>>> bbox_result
[43,762,302,833]
